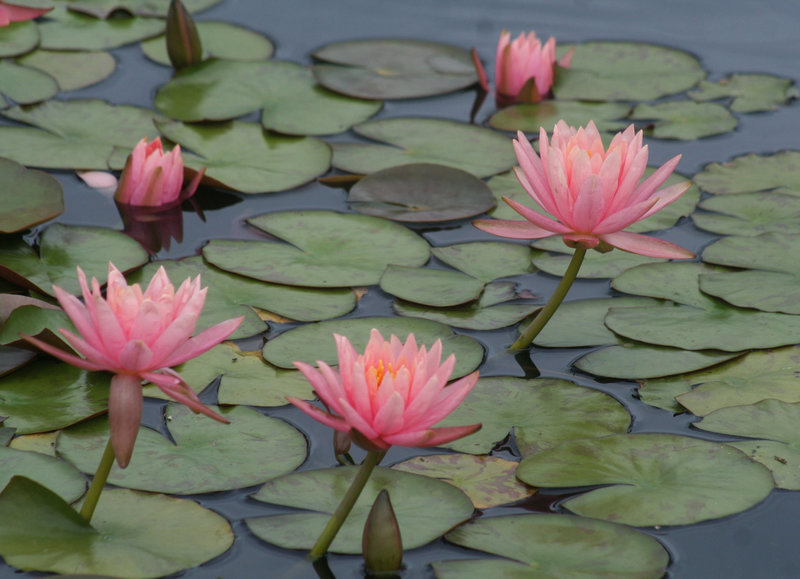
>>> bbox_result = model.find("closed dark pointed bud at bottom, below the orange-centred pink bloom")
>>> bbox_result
[361,489,403,576]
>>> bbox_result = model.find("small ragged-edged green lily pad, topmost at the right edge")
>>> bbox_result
[689,74,797,113]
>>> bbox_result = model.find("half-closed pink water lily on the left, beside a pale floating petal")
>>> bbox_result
[114,137,205,207]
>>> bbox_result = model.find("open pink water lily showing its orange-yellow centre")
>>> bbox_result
[288,329,481,450]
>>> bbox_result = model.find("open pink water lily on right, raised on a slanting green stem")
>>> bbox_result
[473,121,694,259]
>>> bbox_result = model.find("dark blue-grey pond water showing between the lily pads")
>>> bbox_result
[0,0,800,579]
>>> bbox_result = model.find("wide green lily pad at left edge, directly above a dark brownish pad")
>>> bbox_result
[0,99,164,170]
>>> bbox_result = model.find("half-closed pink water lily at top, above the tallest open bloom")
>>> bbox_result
[495,30,573,106]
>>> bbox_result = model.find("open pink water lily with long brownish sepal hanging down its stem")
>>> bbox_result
[23,263,243,468]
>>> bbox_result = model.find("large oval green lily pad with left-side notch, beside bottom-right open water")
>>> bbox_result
[517,434,774,527]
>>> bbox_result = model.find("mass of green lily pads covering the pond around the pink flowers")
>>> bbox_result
[0,0,800,578]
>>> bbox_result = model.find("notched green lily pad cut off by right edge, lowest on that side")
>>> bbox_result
[695,400,800,490]
